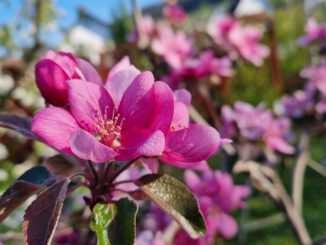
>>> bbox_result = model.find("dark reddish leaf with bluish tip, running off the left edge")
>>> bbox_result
[0,166,53,223]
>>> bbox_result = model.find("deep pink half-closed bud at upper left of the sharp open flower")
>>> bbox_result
[35,50,101,106]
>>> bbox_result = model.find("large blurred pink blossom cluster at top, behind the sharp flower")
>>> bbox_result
[128,8,269,92]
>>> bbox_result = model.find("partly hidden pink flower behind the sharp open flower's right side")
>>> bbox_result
[160,89,230,170]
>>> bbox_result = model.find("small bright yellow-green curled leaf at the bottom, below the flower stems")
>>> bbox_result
[90,203,115,245]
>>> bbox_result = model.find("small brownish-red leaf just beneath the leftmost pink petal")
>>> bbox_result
[43,155,76,176]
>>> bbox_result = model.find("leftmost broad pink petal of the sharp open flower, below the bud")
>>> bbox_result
[32,107,80,153]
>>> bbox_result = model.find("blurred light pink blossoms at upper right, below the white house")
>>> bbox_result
[208,16,269,66]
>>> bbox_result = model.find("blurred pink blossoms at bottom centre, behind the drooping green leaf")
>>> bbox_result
[136,170,250,245]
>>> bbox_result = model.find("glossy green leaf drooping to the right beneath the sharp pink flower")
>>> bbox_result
[136,174,206,239]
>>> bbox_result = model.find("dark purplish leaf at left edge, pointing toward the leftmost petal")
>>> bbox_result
[0,114,38,139]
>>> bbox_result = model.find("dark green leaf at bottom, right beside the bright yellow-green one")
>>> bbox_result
[108,198,138,245]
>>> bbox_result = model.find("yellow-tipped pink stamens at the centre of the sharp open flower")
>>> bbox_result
[95,106,125,149]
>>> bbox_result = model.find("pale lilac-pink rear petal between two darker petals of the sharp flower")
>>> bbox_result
[105,68,140,108]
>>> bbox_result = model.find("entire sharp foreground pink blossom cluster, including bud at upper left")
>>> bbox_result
[32,51,222,170]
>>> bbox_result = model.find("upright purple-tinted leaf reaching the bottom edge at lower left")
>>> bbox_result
[23,178,69,245]
